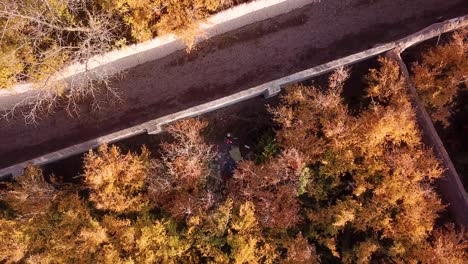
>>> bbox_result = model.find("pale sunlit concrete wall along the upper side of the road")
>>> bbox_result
[0,0,316,111]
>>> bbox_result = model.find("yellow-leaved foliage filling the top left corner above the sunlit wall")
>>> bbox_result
[0,0,112,88]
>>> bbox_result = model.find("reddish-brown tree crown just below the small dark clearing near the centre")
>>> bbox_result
[228,149,304,229]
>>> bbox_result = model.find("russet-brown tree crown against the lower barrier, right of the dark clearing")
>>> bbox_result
[272,68,352,162]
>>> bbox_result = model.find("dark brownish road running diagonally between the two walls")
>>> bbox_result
[0,0,468,167]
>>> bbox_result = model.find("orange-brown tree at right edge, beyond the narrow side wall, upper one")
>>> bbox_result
[412,28,468,126]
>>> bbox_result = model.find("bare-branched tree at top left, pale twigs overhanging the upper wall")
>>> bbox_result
[0,0,120,123]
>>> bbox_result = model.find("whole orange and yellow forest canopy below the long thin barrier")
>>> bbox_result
[0,58,468,264]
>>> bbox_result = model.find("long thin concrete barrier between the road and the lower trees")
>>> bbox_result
[0,16,468,177]
